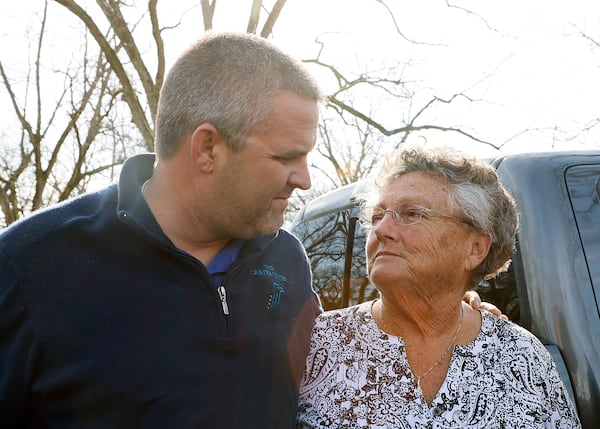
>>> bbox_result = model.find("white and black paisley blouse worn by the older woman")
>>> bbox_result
[297,301,581,429]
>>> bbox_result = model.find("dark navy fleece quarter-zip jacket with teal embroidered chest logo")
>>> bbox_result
[0,154,321,429]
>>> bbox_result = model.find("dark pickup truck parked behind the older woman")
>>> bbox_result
[290,151,600,429]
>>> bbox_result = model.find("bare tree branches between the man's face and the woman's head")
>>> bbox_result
[307,49,499,191]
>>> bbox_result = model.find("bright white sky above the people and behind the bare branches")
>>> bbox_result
[0,0,600,156]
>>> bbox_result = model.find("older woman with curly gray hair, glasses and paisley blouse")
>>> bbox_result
[298,148,580,428]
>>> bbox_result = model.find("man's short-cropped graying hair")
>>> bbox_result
[156,33,321,158]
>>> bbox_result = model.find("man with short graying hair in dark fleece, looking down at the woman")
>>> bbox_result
[0,34,321,429]
